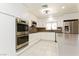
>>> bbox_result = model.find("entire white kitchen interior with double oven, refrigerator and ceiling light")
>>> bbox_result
[0,3,79,56]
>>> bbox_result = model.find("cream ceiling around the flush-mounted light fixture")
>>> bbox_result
[23,3,79,18]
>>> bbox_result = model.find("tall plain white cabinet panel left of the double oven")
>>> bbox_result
[0,13,16,56]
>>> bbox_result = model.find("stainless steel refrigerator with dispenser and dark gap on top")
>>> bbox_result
[64,19,79,34]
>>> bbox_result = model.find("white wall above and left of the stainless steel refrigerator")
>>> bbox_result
[58,13,79,30]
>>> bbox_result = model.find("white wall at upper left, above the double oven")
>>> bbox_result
[0,3,37,26]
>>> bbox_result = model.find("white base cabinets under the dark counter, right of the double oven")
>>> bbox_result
[29,32,55,43]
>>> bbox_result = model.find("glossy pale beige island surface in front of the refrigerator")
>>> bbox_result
[57,34,79,56]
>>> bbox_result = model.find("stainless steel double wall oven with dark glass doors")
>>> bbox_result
[16,18,29,50]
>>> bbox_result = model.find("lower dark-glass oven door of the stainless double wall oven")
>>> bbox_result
[16,35,29,49]
